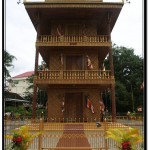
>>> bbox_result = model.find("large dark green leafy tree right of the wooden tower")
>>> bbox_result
[104,44,144,111]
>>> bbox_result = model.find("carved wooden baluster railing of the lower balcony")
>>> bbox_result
[35,70,111,80]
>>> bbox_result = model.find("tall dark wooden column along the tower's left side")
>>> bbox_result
[32,15,40,121]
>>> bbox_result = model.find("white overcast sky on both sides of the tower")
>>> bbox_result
[5,0,144,77]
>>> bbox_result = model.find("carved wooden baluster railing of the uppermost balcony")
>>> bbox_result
[36,35,110,45]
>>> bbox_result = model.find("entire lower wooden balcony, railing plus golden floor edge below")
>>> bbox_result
[34,70,114,85]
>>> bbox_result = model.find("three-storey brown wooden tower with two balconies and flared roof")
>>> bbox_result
[24,0,124,121]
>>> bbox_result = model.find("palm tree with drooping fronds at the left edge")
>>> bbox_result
[4,50,16,80]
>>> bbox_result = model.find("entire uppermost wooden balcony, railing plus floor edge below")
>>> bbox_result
[36,35,111,46]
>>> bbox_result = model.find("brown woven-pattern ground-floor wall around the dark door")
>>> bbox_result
[48,89,100,121]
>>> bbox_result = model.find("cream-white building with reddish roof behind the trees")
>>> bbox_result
[8,71,34,97]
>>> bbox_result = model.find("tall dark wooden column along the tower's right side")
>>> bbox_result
[108,12,116,122]
